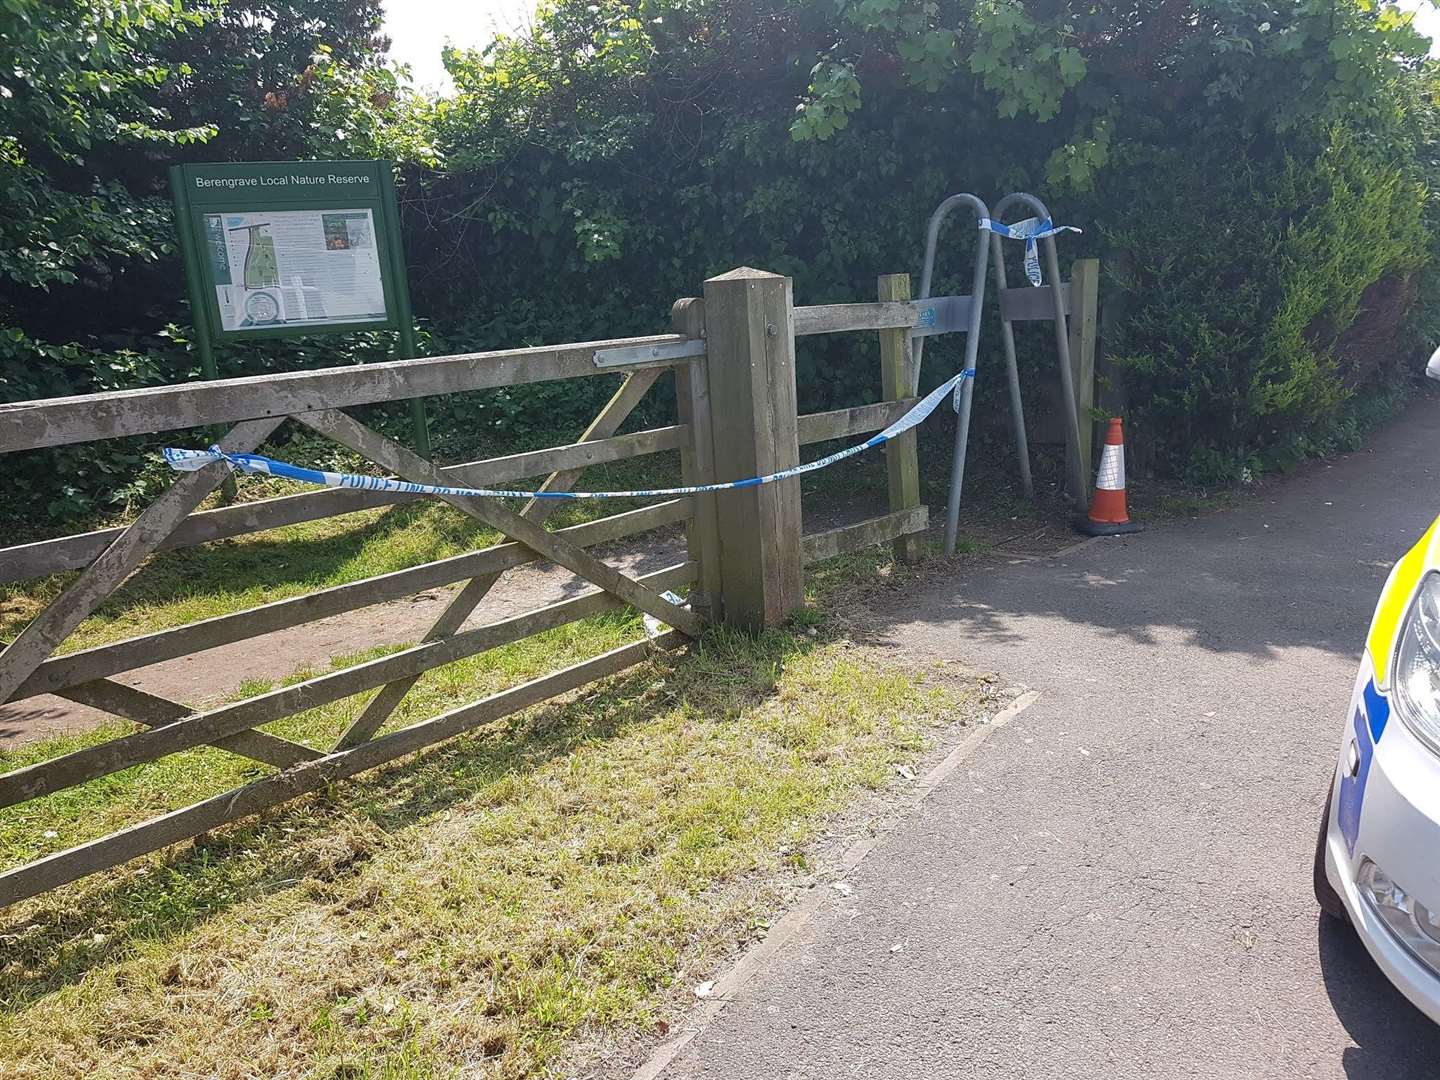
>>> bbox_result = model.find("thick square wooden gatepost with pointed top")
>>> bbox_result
[706,266,804,629]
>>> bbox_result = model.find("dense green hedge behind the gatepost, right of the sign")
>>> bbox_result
[412,0,1434,489]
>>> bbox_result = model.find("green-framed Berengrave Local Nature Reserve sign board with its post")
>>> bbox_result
[170,161,431,456]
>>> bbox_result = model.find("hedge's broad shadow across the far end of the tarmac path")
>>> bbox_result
[852,400,1440,668]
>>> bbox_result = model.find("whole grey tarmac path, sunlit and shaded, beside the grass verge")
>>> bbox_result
[664,400,1440,1080]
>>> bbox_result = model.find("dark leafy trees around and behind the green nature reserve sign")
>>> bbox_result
[0,0,435,524]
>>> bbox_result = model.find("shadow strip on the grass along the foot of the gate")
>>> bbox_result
[0,628,821,1012]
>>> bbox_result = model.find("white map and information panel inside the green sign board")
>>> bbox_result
[204,209,389,331]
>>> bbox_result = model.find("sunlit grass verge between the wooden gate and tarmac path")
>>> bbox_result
[0,593,985,1080]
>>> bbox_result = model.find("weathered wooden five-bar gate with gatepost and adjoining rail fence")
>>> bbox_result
[0,269,944,906]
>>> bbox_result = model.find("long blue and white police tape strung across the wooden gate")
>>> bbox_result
[164,367,975,498]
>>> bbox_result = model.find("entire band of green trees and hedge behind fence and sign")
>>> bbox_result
[0,0,1440,532]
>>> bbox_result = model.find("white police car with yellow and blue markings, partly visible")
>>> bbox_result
[1315,350,1440,1022]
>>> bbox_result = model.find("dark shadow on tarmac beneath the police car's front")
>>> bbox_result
[1316,916,1440,1080]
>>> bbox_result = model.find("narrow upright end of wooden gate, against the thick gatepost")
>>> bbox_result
[670,297,720,622]
